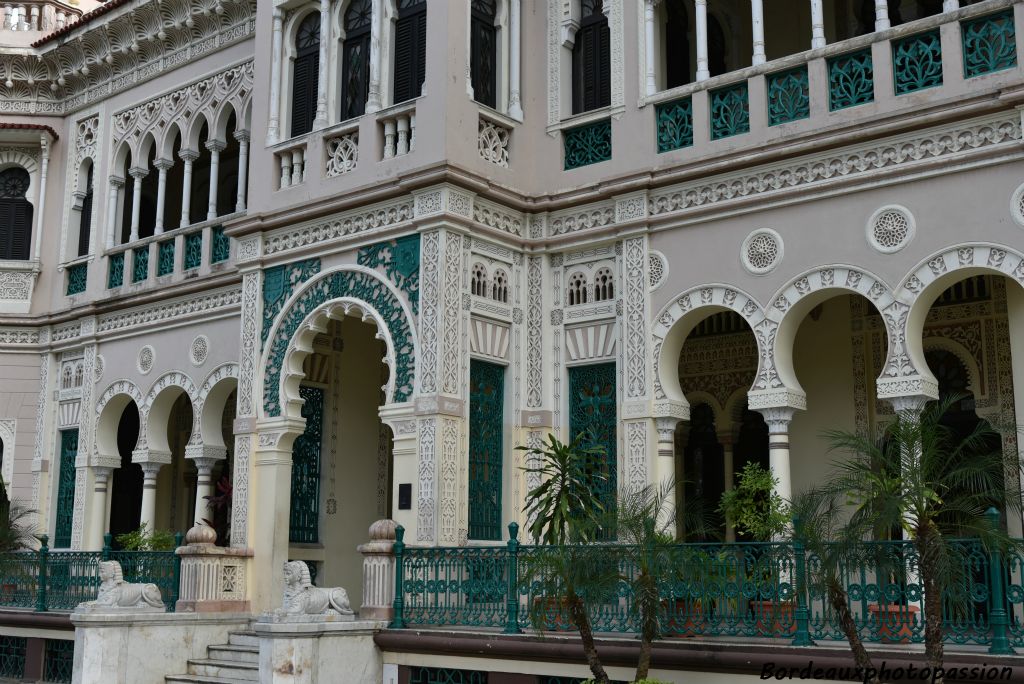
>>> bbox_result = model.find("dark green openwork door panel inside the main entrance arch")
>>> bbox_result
[288,385,324,544]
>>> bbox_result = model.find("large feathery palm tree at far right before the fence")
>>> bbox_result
[812,395,1022,672]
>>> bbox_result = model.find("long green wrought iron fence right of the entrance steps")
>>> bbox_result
[391,523,1024,653]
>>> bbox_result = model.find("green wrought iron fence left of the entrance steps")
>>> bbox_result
[0,535,181,612]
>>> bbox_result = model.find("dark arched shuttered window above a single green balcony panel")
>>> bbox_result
[572,0,611,114]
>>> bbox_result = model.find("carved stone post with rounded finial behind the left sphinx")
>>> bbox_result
[174,524,253,612]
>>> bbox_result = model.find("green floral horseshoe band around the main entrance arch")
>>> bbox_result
[263,271,416,416]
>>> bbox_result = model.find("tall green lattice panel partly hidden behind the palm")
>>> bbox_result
[569,364,618,532]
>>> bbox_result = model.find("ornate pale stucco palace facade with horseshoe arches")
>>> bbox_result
[0,0,1024,674]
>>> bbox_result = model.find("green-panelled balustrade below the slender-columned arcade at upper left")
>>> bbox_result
[103,221,231,294]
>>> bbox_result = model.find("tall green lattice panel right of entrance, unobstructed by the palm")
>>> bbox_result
[469,358,505,542]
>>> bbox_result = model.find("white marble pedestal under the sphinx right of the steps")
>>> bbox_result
[253,614,387,684]
